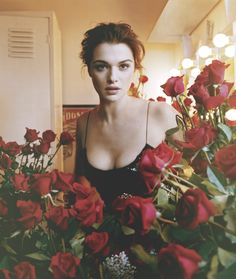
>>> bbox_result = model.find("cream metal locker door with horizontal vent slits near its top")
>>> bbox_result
[0,15,51,143]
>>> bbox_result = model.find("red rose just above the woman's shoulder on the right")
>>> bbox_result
[161,76,184,97]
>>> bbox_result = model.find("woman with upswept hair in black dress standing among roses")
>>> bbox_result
[75,23,179,206]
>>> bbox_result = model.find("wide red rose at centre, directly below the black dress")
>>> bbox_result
[112,196,156,234]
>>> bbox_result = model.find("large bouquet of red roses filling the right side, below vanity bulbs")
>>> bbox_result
[133,60,236,279]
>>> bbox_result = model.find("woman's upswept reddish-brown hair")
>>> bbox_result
[80,23,145,70]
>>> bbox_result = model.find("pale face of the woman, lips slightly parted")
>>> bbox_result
[89,43,134,101]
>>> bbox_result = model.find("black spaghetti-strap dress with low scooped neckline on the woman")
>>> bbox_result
[76,103,152,206]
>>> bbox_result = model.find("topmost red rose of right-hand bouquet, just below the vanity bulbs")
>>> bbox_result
[208,60,229,84]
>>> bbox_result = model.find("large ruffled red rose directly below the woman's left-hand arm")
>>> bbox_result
[71,177,104,227]
